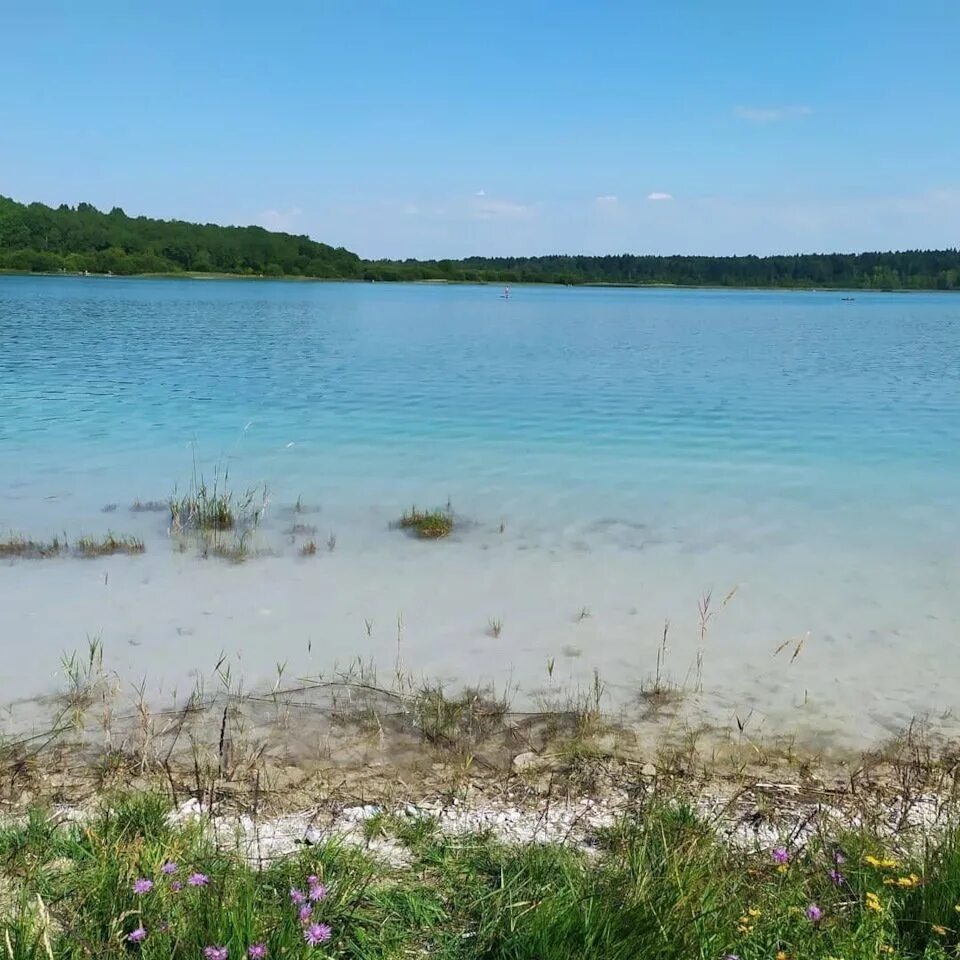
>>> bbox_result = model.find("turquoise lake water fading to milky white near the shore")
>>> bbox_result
[0,277,960,742]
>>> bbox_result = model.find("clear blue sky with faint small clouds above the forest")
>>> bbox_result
[0,0,960,258]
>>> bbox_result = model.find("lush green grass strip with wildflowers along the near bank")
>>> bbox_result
[0,795,960,960]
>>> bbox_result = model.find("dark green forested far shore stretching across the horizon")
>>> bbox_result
[0,196,960,290]
